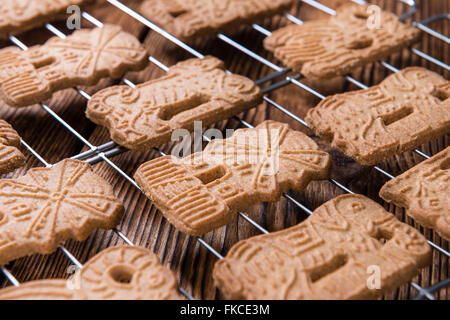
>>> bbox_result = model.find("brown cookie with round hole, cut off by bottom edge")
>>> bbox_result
[0,246,183,300]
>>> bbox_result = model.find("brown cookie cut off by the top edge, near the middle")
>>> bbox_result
[140,0,293,41]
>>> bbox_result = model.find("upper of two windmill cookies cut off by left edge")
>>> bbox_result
[0,25,148,107]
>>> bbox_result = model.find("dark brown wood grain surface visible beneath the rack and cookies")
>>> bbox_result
[0,0,450,299]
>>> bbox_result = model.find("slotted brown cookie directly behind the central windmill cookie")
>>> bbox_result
[86,57,262,151]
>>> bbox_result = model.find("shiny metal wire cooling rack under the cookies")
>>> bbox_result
[0,0,450,300]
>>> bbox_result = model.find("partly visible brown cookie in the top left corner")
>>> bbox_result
[0,0,90,39]
